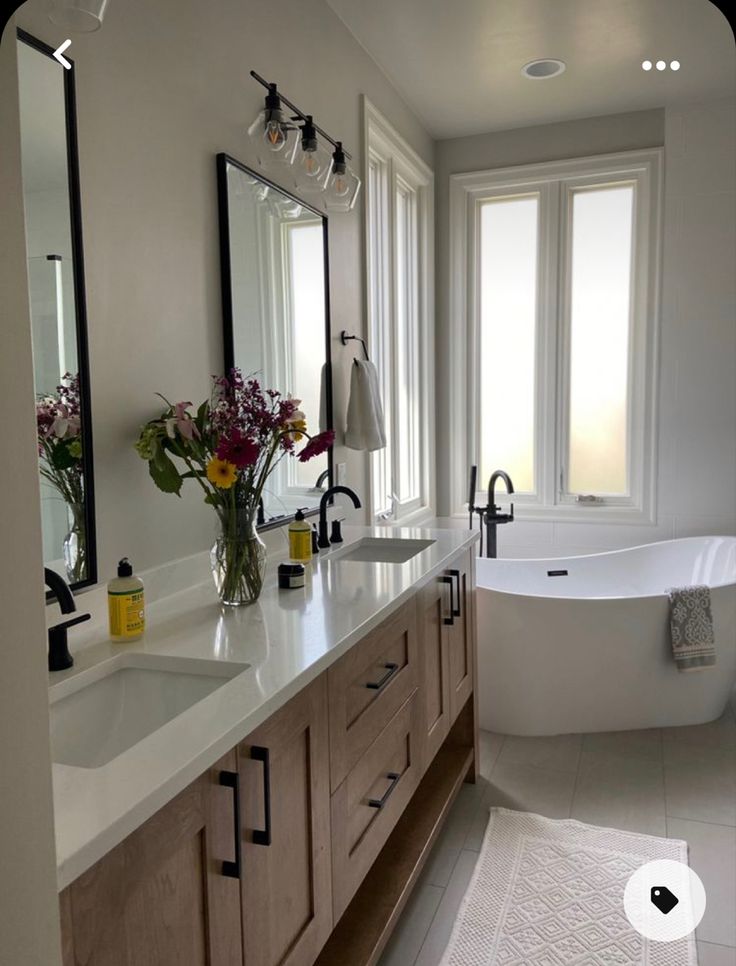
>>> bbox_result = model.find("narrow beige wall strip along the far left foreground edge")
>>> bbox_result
[0,25,60,966]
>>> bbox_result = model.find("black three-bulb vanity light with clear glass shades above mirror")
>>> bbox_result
[248,70,361,212]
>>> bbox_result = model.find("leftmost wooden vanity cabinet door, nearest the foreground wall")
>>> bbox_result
[59,751,242,966]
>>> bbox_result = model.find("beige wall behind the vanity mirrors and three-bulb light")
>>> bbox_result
[18,0,433,579]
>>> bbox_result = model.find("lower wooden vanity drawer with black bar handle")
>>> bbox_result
[330,691,421,923]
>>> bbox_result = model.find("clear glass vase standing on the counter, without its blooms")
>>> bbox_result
[210,511,266,607]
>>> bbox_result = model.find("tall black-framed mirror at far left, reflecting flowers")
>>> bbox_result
[17,30,97,589]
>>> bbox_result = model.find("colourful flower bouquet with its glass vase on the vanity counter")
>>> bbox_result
[135,369,335,605]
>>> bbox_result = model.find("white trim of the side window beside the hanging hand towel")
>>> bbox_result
[361,94,437,526]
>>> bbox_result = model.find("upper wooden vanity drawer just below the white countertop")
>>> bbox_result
[327,598,418,792]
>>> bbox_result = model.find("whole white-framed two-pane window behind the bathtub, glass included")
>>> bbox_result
[450,149,662,522]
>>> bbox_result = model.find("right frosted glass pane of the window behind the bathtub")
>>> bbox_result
[567,184,634,495]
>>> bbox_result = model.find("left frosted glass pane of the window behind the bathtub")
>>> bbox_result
[478,195,539,493]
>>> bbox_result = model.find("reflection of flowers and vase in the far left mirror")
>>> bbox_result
[36,372,87,583]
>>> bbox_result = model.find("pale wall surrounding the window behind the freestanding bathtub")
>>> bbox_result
[436,101,736,557]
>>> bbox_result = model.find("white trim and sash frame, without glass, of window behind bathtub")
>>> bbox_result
[448,147,664,524]
